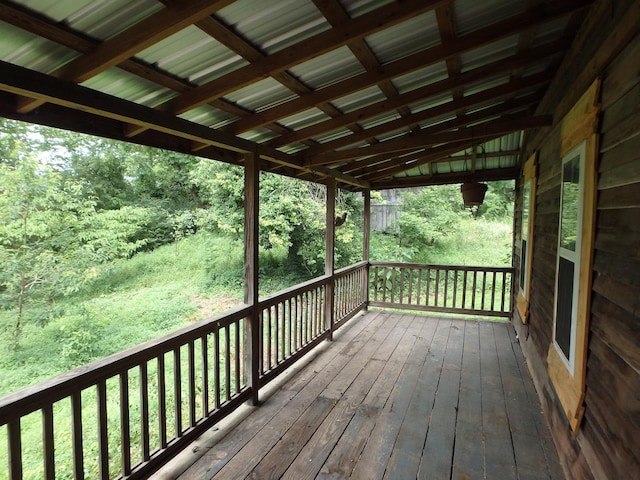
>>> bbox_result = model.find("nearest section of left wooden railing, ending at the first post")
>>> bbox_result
[0,308,250,479]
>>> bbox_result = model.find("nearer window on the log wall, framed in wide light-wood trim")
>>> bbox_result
[547,80,600,431]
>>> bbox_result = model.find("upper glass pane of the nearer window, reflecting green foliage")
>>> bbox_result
[560,155,580,252]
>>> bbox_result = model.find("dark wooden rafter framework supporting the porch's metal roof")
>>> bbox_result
[0,0,593,189]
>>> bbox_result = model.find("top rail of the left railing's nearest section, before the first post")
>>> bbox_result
[0,306,251,425]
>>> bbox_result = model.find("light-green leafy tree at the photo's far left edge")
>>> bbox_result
[0,154,95,345]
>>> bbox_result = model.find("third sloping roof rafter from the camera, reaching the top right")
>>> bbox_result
[225,0,593,134]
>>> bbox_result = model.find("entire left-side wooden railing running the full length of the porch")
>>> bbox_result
[0,262,368,480]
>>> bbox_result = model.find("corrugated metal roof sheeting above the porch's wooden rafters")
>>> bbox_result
[0,0,588,190]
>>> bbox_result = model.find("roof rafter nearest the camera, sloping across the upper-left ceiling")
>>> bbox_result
[18,0,233,113]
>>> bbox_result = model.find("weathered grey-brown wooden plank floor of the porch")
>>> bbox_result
[172,311,564,480]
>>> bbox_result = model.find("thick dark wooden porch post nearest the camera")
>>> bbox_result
[244,153,260,406]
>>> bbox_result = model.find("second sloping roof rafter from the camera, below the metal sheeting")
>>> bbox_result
[162,0,448,114]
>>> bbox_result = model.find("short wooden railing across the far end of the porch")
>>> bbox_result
[369,262,513,317]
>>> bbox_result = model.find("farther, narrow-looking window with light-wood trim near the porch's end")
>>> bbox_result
[516,153,537,323]
